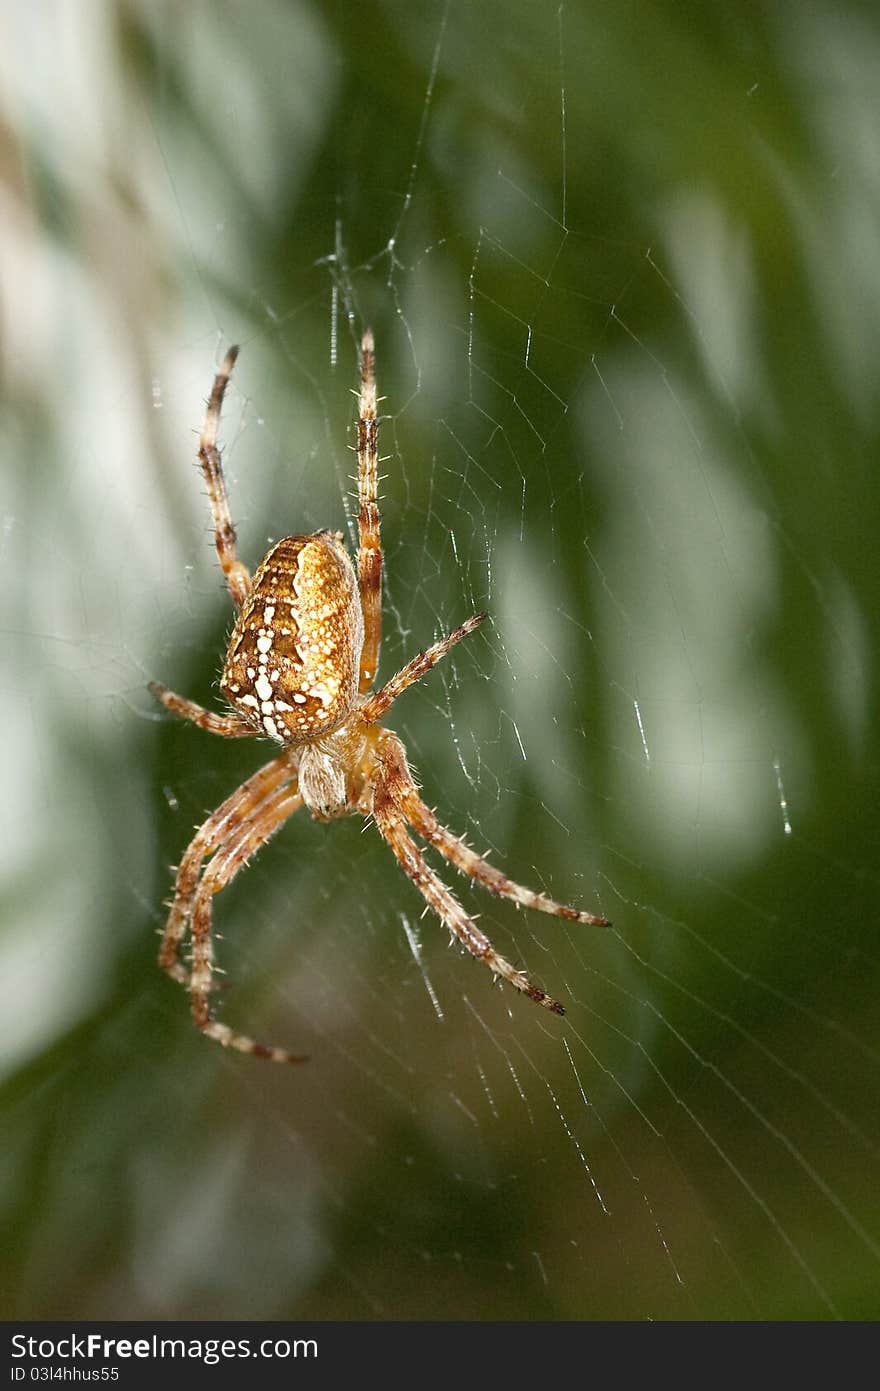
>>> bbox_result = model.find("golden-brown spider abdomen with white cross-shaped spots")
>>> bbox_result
[220,531,364,744]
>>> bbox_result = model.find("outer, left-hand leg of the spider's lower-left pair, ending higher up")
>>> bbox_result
[158,753,295,985]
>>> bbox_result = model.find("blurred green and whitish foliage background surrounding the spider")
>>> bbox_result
[0,0,880,1319]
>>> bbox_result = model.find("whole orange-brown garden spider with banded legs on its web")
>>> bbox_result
[150,330,608,1063]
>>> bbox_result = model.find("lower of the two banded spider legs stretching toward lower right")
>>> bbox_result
[373,762,566,1014]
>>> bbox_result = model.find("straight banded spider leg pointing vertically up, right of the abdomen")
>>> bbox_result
[357,328,382,696]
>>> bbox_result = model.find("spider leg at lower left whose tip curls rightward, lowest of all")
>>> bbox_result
[189,787,307,1063]
